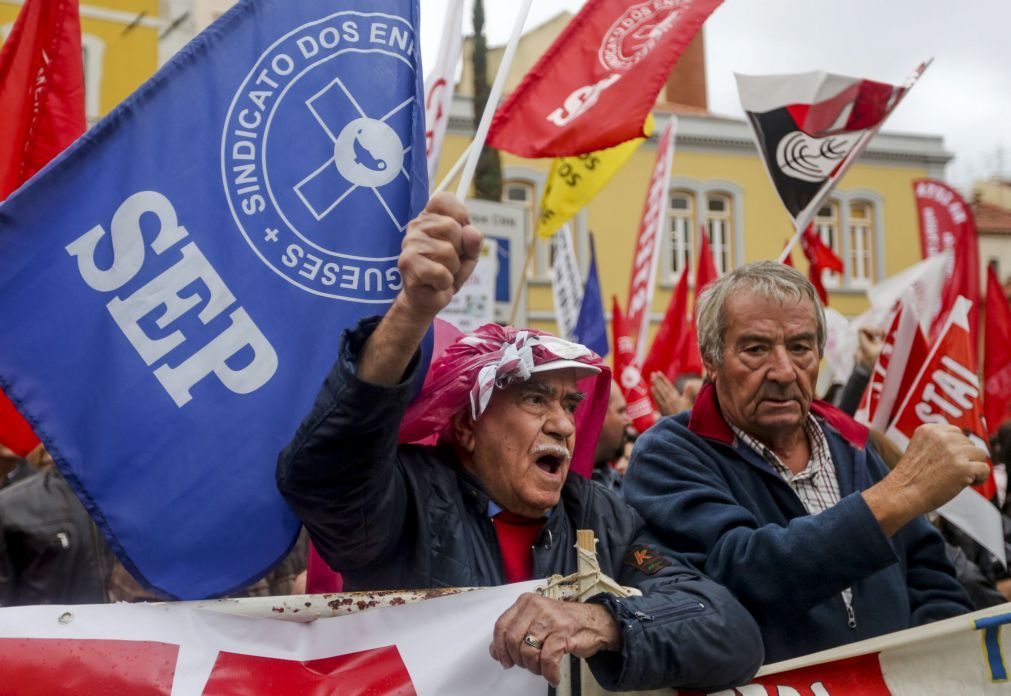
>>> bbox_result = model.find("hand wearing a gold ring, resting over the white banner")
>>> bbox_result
[488,593,622,686]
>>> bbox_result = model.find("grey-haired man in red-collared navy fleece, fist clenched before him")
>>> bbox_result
[624,262,989,662]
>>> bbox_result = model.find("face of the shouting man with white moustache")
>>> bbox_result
[455,369,584,517]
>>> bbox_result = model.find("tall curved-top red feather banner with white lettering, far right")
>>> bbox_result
[913,179,980,338]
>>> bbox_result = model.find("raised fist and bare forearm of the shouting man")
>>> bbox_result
[358,193,481,386]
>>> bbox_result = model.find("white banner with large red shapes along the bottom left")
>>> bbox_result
[0,582,548,696]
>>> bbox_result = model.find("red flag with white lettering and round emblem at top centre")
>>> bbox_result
[487,0,723,158]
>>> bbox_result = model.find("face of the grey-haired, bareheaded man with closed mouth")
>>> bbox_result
[706,290,820,443]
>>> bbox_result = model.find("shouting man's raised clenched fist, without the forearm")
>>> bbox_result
[396,193,481,322]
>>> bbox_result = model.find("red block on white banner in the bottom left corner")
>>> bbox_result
[0,638,179,696]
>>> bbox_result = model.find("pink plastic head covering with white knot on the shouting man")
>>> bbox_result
[399,324,611,476]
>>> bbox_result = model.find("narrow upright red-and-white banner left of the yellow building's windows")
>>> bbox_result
[627,118,676,360]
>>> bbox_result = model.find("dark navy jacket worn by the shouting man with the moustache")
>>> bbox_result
[277,321,762,690]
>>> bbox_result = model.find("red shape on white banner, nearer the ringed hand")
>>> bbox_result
[203,645,418,696]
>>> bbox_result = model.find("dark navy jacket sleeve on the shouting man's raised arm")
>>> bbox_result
[276,318,419,571]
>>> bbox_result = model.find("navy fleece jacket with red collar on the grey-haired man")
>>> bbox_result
[624,384,972,663]
